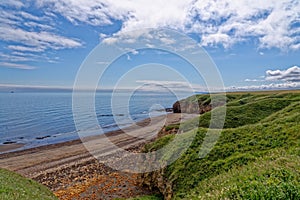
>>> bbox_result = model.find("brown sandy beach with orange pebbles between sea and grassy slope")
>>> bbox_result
[0,113,196,199]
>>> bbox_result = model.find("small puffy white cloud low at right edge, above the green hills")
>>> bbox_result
[266,66,300,82]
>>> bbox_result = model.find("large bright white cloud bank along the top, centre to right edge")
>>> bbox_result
[37,0,300,50]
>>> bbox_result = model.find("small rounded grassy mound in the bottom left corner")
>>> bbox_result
[0,169,57,200]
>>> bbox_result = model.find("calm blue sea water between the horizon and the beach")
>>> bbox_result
[0,92,184,152]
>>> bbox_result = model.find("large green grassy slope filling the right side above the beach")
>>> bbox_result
[137,91,300,199]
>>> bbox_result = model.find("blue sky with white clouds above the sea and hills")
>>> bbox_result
[0,0,300,91]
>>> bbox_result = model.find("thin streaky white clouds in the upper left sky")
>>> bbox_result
[0,5,82,62]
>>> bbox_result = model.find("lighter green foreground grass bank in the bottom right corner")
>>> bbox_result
[186,150,300,200]
